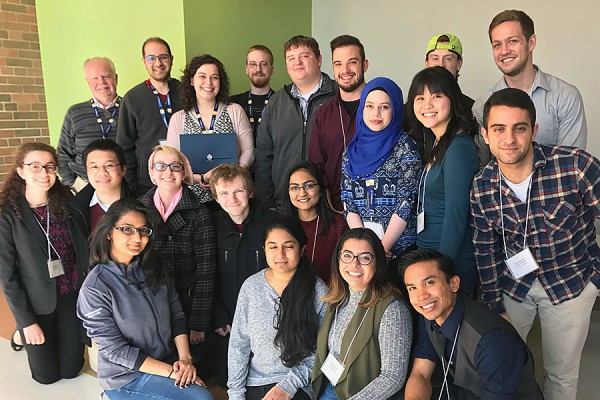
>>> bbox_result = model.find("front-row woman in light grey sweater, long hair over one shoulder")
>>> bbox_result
[227,216,327,400]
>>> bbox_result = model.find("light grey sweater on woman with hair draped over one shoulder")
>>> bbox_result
[227,271,327,400]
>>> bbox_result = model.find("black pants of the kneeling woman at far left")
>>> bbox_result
[21,293,84,384]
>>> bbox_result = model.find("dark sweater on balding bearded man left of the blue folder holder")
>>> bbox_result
[117,79,181,189]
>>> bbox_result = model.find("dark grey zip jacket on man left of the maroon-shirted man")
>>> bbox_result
[255,74,337,209]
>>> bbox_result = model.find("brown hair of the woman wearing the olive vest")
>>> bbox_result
[323,228,401,310]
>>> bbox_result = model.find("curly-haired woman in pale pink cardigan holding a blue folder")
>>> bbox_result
[167,54,254,207]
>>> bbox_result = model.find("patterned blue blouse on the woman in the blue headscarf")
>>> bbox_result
[342,134,422,256]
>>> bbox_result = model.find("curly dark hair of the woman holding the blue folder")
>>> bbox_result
[181,54,230,111]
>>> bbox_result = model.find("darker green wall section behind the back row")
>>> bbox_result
[183,0,312,94]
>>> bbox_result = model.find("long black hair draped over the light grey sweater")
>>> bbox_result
[264,215,319,368]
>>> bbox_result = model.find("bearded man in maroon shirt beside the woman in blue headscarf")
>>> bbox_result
[308,35,369,212]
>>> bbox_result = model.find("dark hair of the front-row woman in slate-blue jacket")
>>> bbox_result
[89,197,168,290]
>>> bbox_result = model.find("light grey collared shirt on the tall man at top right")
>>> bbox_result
[473,65,587,149]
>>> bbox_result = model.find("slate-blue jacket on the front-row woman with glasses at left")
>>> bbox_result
[77,259,187,390]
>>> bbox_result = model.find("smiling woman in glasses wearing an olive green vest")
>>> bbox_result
[312,228,412,400]
